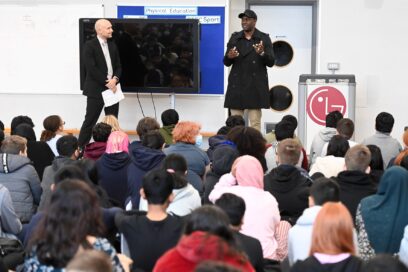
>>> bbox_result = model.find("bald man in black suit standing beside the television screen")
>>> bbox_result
[78,19,122,148]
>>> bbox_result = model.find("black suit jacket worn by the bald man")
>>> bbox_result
[83,38,122,99]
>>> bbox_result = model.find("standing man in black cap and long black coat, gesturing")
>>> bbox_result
[224,9,275,130]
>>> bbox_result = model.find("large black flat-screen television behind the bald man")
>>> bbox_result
[79,19,200,93]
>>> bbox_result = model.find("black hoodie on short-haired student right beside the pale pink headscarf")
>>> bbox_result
[264,165,312,225]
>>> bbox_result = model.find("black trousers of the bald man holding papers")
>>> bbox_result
[78,97,119,147]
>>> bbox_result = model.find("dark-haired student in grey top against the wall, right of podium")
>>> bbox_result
[362,112,402,167]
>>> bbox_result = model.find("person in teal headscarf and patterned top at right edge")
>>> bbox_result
[356,166,408,260]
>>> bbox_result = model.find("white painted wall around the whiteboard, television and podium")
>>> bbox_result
[0,0,408,144]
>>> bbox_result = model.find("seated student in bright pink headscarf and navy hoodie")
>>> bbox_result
[96,131,130,208]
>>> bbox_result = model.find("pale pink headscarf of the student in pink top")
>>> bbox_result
[231,155,264,190]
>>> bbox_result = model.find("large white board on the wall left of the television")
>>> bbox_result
[0,4,104,94]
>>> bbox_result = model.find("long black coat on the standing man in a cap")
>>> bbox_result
[224,29,275,109]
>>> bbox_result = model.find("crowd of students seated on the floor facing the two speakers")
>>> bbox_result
[0,110,408,272]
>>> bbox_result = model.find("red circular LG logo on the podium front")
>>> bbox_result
[306,86,346,126]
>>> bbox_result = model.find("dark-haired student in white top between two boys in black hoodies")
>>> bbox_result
[309,135,350,178]
